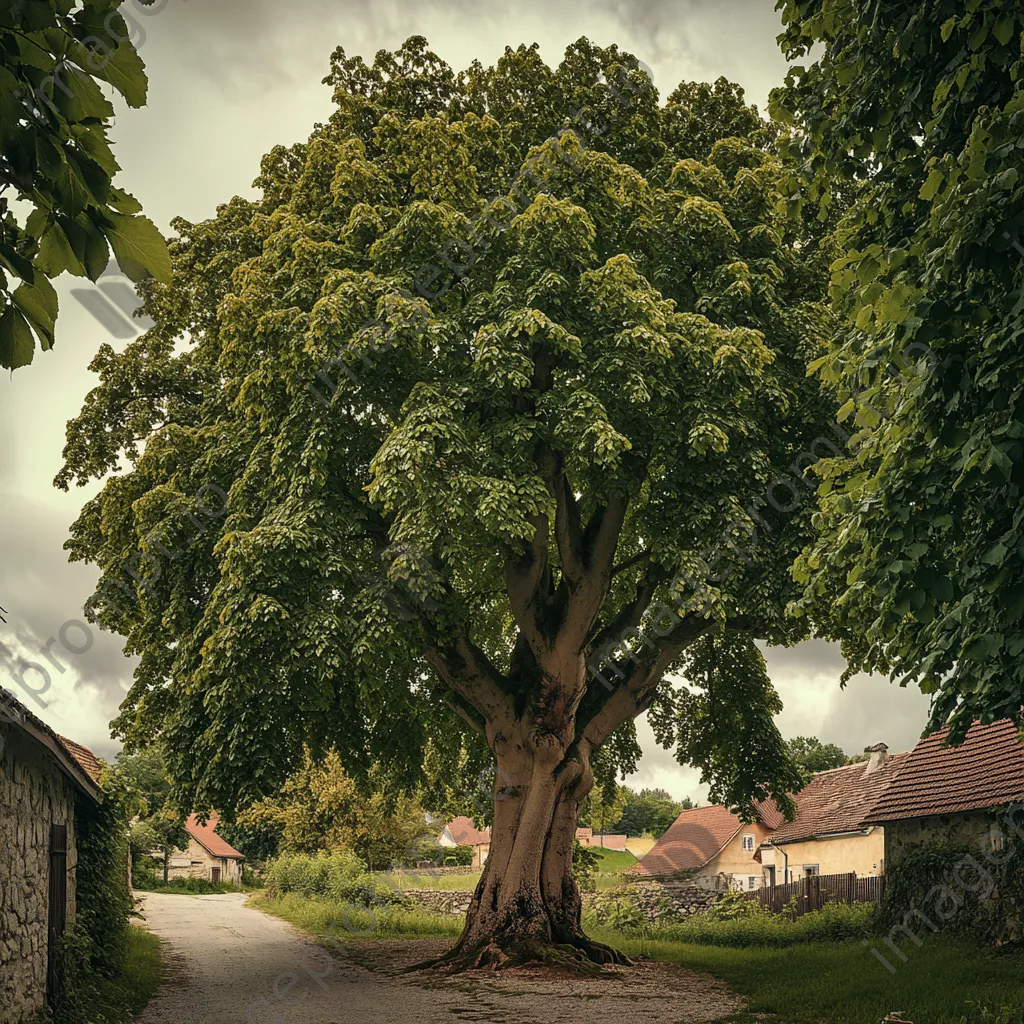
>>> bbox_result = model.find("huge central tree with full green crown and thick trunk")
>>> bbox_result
[59,38,833,964]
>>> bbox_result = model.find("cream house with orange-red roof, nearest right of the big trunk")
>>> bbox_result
[627,802,784,890]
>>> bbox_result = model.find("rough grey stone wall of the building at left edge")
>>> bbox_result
[0,722,78,1024]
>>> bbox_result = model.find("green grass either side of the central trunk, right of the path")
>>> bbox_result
[254,895,1024,1024]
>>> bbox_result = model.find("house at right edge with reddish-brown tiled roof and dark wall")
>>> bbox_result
[867,720,1024,869]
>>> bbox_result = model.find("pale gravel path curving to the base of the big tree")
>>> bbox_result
[140,893,740,1024]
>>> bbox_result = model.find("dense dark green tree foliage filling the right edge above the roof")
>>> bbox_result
[773,0,1024,739]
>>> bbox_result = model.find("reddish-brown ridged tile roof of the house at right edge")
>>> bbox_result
[867,720,1024,823]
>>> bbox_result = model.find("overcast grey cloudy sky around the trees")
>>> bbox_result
[0,0,927,797]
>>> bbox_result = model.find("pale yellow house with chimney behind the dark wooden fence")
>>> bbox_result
[758,743,909,885]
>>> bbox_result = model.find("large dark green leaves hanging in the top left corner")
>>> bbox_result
[0,0,171,370]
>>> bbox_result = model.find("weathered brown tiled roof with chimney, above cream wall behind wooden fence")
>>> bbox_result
[766,754,910,845]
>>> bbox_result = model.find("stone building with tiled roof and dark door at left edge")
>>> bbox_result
[0,688,103,1024]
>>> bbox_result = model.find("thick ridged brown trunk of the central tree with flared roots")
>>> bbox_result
[423,743,630,972]
